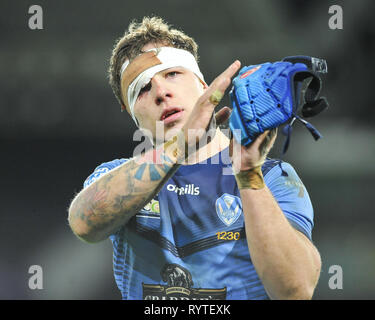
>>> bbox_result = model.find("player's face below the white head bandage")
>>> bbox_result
[134,44,207,143]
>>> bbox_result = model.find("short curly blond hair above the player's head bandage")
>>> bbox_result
[108,17,198,105]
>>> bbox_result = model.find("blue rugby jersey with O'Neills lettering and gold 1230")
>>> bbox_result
[84,151,313,300]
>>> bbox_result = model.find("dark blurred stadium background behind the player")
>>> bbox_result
[0,0,375,299]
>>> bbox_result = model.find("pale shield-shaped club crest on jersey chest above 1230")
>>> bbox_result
[216,193,242,227]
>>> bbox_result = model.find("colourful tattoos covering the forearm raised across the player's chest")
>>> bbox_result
[74,149,179,236]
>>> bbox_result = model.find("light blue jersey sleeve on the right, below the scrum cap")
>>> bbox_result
[264,162,314,240]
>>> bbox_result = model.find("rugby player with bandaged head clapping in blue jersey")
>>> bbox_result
[68,17,321,300]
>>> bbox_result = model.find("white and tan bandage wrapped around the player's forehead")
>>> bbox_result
[120,47,205,125]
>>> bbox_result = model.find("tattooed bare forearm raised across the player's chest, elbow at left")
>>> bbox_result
[68,142,181,242]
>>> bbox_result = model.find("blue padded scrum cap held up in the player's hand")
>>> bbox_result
[229,61,310,146]
